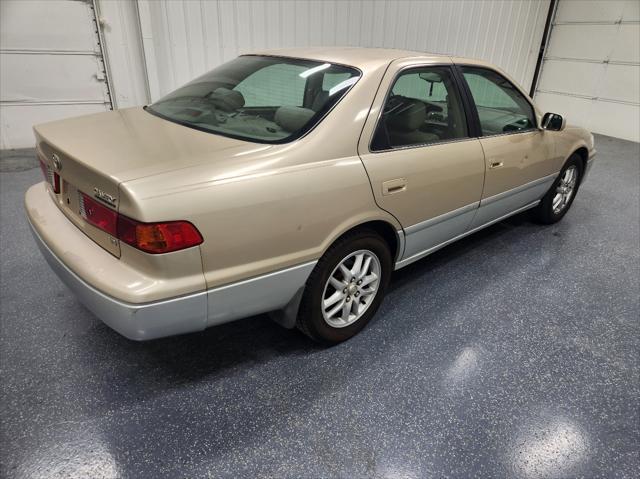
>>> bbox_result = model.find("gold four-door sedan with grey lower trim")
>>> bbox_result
[25,48,595,343]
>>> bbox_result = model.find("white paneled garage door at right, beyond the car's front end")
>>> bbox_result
[536,0,640,141]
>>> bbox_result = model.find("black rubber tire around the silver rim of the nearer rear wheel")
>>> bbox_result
[296,229,392,345]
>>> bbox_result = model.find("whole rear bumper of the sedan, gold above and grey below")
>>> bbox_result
[25,183,207,340]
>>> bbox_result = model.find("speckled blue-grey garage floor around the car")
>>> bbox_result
[0,137,640,478]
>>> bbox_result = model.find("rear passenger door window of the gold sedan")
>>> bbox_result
[371,67,468,151]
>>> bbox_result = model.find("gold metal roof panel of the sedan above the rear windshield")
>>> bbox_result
[250,47,451,70]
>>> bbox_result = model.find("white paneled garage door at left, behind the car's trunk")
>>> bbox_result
[0,0,111,149]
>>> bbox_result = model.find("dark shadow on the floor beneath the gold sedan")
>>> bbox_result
[77,214,539,394]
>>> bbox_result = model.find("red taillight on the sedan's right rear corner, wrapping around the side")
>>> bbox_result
[79,193,203,254]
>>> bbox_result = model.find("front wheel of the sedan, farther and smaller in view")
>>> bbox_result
[532,154,582,224]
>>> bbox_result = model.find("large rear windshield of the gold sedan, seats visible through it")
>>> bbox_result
[147,55,360,143]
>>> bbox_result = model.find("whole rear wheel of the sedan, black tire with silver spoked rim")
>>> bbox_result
[296,230,392,344]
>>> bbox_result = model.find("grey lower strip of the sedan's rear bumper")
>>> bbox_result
[30,222,207,341]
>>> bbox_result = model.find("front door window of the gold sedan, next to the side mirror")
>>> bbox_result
[462,67,536,136]
